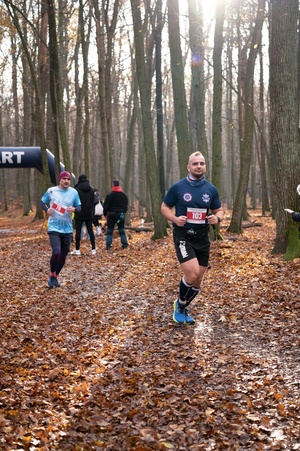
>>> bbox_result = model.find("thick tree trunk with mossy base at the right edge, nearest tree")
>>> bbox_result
[270,0,300,260]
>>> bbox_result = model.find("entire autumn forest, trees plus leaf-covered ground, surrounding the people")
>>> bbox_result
[0,0,300,451]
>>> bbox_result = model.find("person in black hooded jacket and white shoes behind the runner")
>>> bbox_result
[71,174,96,255]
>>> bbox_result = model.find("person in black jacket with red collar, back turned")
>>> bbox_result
[103,179,128,250]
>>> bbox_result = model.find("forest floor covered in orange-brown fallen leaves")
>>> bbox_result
[0,214,300,451]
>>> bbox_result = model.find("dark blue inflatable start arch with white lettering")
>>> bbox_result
[0,147,76,185]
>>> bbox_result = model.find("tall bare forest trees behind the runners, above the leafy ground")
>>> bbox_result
[0,0,300,259]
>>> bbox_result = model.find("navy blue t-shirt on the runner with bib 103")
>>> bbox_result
[163,178,221,230]
